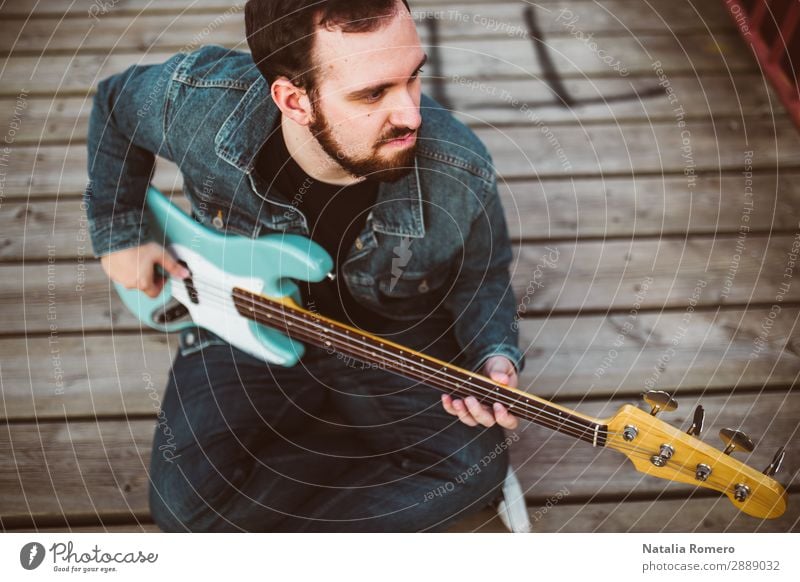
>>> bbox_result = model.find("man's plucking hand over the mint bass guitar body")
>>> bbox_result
[100,242,189,297]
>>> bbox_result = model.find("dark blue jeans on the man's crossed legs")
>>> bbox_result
[150,319,508,532]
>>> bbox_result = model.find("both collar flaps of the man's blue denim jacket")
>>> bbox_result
[214,75,425,238]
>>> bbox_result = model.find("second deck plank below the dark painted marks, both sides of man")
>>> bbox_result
[6,171,800,261]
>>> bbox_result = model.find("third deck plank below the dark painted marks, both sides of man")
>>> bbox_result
[0,235,800,333]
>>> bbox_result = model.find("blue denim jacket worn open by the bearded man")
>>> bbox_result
[85,46,524,370]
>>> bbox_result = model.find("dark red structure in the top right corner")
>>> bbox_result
[724,0,800,129]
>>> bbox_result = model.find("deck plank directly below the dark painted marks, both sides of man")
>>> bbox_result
[4,120,800,198]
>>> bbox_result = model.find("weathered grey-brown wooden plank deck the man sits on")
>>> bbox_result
[0,0,800,532]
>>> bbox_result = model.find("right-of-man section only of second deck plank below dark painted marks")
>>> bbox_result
[499,170,800,240]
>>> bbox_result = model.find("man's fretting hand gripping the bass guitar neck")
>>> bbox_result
[442,356,519,430]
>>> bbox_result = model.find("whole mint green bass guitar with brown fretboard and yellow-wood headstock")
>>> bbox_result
[117,187,786,518]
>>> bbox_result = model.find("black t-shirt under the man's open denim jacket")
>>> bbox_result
[256,118,386,331]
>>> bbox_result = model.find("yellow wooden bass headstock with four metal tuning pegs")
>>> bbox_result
[604,391,786,519]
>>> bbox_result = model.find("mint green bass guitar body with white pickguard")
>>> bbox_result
[116,186,333,366]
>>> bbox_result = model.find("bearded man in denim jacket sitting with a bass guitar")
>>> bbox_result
[86,0,523,531]
